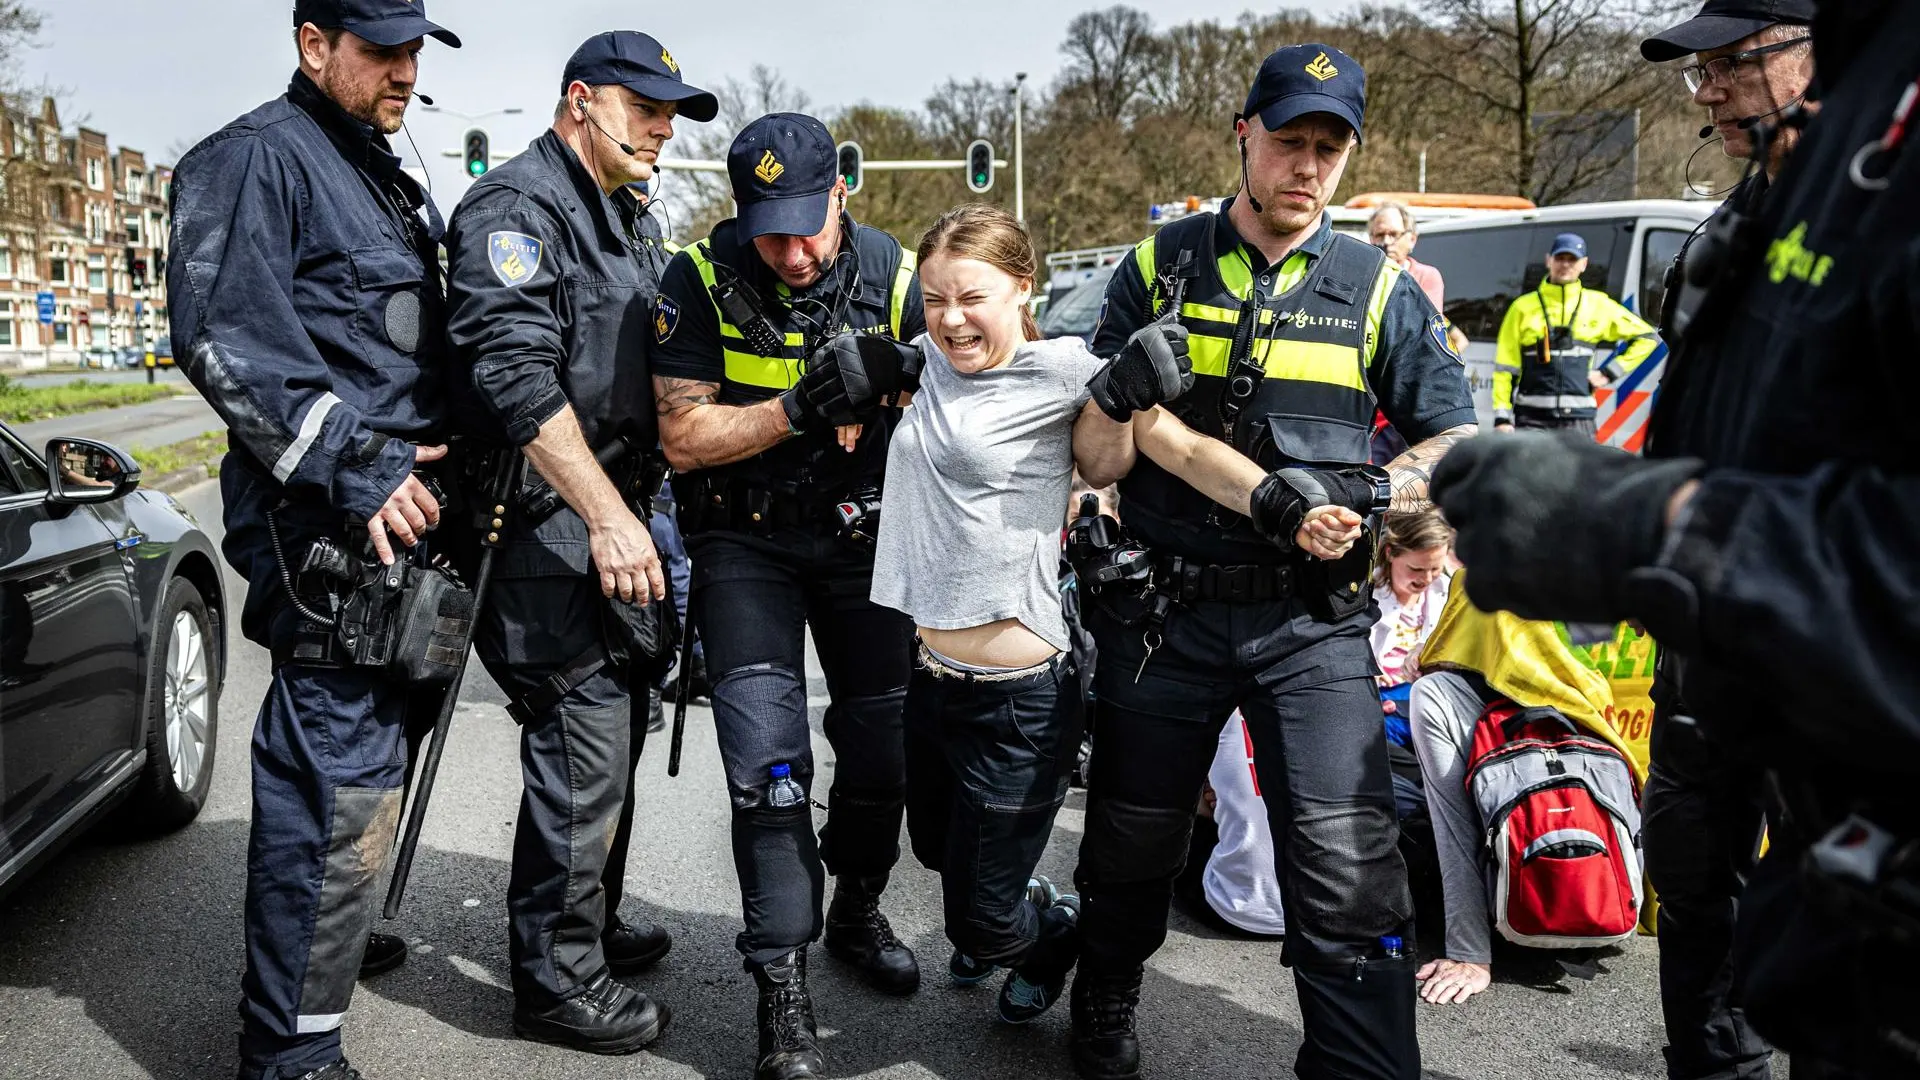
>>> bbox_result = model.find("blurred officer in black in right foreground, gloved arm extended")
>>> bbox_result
[1434,0,1920,1076]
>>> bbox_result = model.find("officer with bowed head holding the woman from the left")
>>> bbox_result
[653,113,925,1080]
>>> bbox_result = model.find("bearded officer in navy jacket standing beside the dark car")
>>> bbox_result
[167,0,459,1080]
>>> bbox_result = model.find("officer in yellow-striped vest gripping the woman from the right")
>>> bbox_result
[1071,44,1473,1080]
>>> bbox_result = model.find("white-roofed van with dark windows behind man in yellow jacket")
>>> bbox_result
[1413,198,1718,450]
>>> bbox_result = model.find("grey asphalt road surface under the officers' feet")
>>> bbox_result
[0,484,1665,1080]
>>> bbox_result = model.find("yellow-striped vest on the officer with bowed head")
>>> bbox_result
[687,229,914,400]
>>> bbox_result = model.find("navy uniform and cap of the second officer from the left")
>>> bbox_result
[447,31,716,1034]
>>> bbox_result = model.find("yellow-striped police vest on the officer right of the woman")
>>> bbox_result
[1135,213,1400,467]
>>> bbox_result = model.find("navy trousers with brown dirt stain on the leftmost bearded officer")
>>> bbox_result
[240,665,415,1080]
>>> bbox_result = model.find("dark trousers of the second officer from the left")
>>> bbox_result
[474,575,647,1005]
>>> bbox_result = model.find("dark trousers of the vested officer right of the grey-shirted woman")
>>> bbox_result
[1077,600,1421,1080]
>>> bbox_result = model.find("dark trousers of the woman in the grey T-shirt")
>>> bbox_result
[906,653,1083,978]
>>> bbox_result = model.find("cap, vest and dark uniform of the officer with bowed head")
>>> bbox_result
[653,113,925,990]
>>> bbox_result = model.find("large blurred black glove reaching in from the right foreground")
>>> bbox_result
[1430,424,1703,623]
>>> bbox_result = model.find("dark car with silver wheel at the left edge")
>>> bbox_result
[0,427,227,896]
